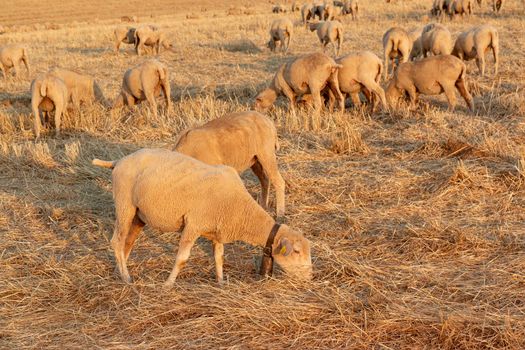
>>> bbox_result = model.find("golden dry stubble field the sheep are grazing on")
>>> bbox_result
[0,0,525,349]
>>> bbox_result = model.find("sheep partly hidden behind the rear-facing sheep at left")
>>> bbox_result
[49,68,107,110]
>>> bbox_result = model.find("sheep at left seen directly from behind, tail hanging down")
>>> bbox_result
[31,74,68,139]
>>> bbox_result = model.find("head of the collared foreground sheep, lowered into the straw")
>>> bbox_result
[272,225,312,280]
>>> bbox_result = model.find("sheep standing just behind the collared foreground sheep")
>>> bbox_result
[173,111,285,217]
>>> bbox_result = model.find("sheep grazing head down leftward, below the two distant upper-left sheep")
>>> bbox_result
[113,59,172,116]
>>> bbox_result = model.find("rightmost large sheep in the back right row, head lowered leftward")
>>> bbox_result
[452,25,499,76]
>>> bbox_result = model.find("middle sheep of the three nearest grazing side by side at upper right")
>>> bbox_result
[329,51,388,109]
